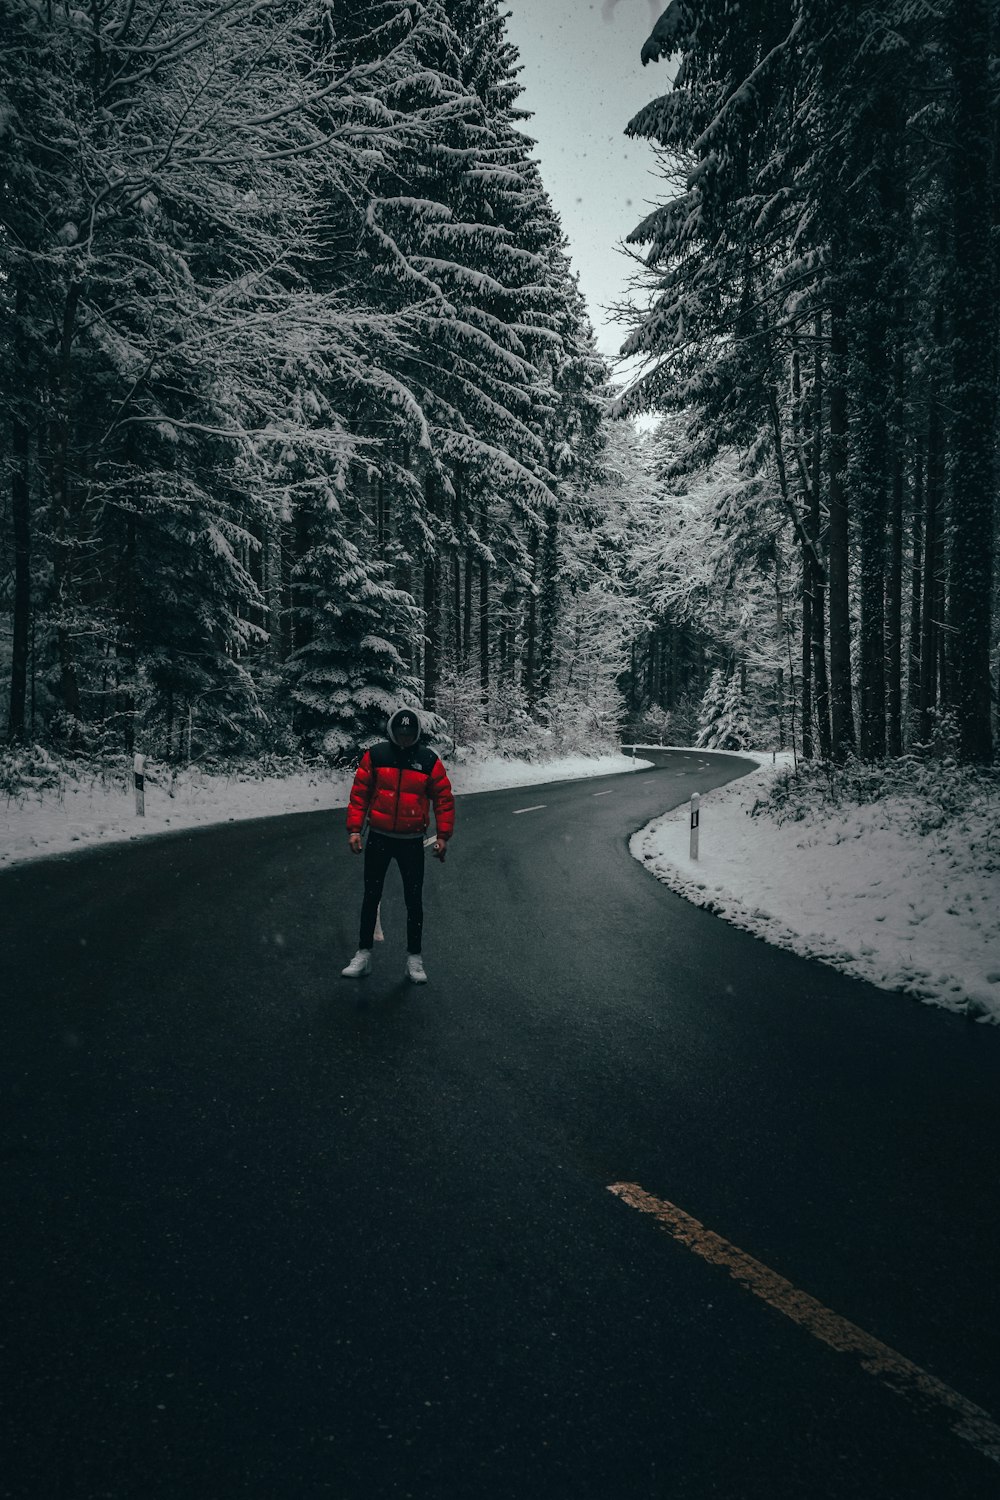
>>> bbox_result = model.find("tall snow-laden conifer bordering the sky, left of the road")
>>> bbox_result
[340,0,611,729]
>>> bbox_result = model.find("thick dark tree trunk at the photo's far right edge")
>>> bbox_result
[949,0,997,762]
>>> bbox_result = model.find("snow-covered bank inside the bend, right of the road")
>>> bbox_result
[630,753,1000,1023]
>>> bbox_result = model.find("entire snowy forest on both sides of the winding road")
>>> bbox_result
[0,0,1000,765]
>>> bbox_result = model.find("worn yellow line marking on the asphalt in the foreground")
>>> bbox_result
[607,1182,1000,1464]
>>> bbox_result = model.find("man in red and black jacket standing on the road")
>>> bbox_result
[342,708,454,984]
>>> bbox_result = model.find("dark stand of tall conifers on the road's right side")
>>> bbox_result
[622,0,1000,762]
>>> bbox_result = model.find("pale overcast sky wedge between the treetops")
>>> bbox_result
[507,0,669,369]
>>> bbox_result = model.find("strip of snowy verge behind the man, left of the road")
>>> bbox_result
[0,755,649,869]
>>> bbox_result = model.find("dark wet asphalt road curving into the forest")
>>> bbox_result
[0,753,1000,1500]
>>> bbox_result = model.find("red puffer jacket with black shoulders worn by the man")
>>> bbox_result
[348,740,454,842]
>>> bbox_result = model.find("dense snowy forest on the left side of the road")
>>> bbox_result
[0,0,629,761]
